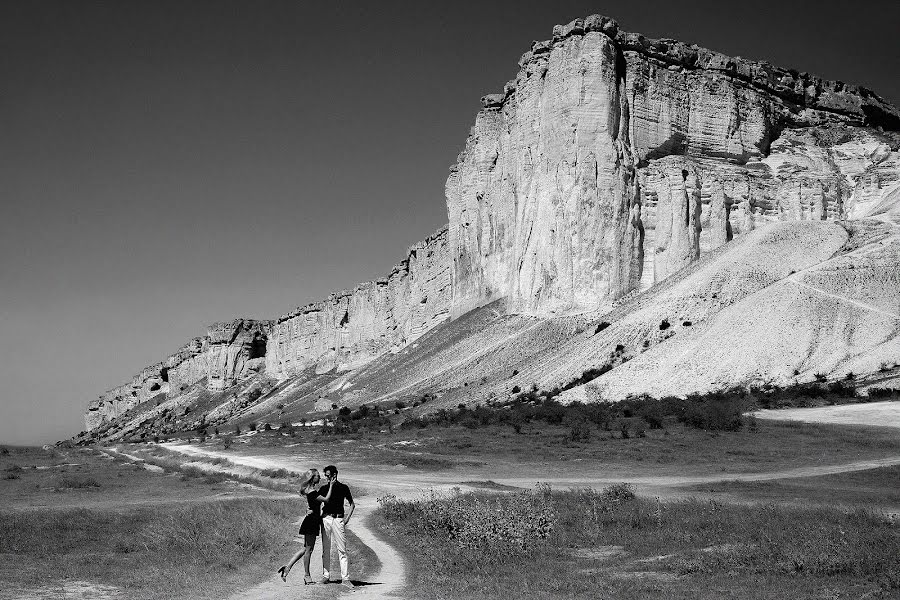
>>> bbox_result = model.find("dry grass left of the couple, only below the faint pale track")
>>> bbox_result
[0,492,299,599]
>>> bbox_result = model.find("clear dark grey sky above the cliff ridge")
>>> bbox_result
[0,0,900,444]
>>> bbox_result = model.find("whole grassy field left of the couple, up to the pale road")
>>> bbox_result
[0,447,377,600]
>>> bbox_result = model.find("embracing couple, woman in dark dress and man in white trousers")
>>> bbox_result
[278,465,355,588]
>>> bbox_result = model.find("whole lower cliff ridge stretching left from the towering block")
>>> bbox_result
[85,228,450,431]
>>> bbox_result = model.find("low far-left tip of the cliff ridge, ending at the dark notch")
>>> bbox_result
[85,319,272,430]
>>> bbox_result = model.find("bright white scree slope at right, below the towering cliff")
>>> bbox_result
[564,222,900,400]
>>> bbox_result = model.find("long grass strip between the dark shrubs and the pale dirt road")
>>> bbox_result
[213,421,900,475]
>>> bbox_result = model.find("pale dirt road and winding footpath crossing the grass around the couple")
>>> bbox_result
[165,438,900,600]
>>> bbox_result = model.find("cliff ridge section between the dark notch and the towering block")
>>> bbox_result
[266,228,450,378]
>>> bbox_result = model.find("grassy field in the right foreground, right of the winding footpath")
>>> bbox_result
[378,486,900,600]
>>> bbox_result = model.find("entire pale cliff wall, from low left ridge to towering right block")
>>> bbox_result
[86,15,900,436]
